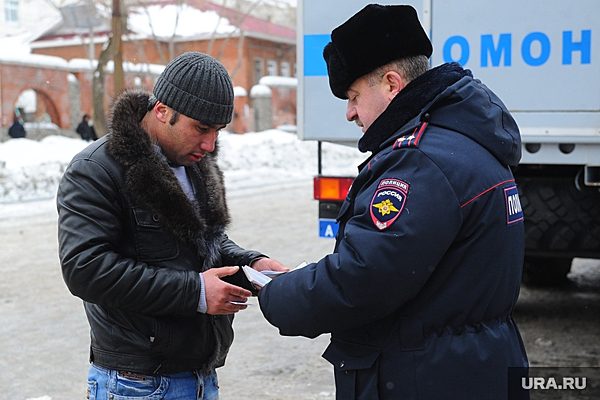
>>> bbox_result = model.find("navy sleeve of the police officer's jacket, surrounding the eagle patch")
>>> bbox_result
[259,150,461,337]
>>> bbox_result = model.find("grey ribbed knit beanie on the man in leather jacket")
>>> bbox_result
[153,52,233,125]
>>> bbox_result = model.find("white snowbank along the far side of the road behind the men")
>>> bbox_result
[0,130,367,212]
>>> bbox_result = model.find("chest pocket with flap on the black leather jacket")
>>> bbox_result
[132,207,179,262]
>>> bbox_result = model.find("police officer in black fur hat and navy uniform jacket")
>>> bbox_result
[259,4,528,400]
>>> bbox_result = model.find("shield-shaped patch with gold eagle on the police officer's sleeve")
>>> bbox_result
[370,178,410,231]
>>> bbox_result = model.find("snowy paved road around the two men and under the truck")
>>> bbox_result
[0,182,600,400]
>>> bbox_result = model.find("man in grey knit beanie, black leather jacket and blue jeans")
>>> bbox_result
[57,53,285,399]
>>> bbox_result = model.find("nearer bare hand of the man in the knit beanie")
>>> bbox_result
[202,267,252,315]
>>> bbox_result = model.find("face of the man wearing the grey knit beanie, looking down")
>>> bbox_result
[156,107,225,165]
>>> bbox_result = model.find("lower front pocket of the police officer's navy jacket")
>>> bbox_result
[323,339,380,400]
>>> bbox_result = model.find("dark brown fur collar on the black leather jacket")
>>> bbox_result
[108,91,229,268]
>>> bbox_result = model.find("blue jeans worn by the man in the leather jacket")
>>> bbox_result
[87,364,219,400]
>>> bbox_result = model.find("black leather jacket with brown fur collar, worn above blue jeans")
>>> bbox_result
[57,93,262,374]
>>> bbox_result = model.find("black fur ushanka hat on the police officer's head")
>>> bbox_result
[323,4,433,99]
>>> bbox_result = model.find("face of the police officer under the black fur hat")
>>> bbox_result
[346,76,393,133]
